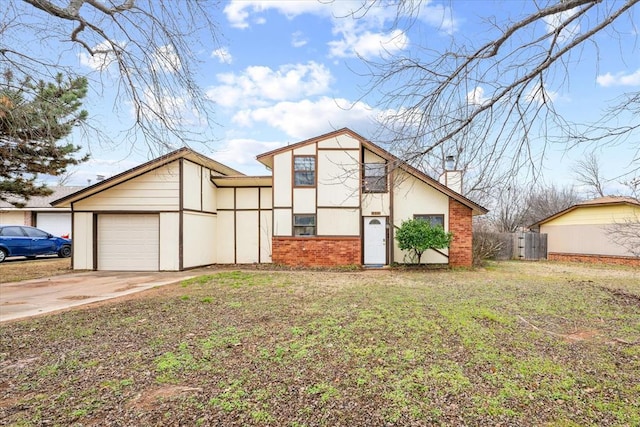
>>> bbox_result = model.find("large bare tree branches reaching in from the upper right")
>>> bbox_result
[367,0,640,185]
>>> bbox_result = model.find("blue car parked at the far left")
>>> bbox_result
[0,225,71,262]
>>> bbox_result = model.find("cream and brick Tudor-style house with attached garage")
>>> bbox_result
[54,129,487,271]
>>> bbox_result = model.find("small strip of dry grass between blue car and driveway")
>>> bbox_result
[0,257,71,283]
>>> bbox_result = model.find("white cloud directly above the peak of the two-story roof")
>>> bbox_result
[233,96,382,140]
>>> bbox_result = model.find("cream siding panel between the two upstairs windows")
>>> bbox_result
[316,150,360,207]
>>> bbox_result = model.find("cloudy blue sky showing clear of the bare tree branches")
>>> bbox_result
[28,0,640,191]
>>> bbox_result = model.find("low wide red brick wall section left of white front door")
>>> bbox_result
[271,237,362,267]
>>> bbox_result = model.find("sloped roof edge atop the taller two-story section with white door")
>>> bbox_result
[257,128,489,215]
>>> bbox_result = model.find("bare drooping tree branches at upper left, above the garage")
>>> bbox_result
[0,0,217,148]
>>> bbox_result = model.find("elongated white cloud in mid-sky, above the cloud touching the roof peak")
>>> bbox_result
[207,61,333,107]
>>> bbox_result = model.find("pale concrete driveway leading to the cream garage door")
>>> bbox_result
[0,270,205,322]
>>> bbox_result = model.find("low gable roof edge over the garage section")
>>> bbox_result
[51,147,245,206]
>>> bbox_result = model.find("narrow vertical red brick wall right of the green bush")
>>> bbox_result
[449,198,473,267]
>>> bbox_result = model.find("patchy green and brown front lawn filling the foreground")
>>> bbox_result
[0,262,640,426]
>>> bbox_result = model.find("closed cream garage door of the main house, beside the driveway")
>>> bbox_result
[98,214,160,271]
